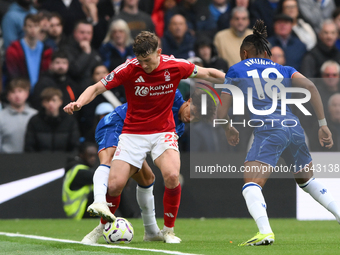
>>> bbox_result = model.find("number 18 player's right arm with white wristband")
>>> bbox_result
[293,73,333,149]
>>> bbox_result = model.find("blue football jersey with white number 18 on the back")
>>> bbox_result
[222,58,299,131]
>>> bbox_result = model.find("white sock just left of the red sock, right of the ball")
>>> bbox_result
[136,184,159,235]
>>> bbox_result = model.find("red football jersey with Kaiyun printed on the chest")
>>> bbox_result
[101,55,196,134]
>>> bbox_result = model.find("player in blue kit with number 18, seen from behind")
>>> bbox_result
[217,20,340,246]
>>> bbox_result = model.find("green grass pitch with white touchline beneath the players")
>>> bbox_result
[0,219,340,255]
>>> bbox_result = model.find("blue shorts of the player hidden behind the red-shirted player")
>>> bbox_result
[95,112,124,153]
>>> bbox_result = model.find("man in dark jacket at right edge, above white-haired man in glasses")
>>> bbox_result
[300,20,340,78]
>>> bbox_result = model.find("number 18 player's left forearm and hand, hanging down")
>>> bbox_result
[217,93,240,146]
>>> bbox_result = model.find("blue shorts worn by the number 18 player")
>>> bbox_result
[245,125,312,172]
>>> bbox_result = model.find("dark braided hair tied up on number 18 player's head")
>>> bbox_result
[241,20,272,57]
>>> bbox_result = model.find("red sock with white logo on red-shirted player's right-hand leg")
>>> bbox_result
[163,184,181,228]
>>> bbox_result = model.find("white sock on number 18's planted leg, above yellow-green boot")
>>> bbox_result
[242,182,273,234]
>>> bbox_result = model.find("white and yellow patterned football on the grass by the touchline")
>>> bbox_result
[103,217,133,244]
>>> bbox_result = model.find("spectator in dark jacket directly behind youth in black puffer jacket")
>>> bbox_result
[31,51,80,109]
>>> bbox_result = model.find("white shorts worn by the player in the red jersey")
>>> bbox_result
[113,132,179,169]
